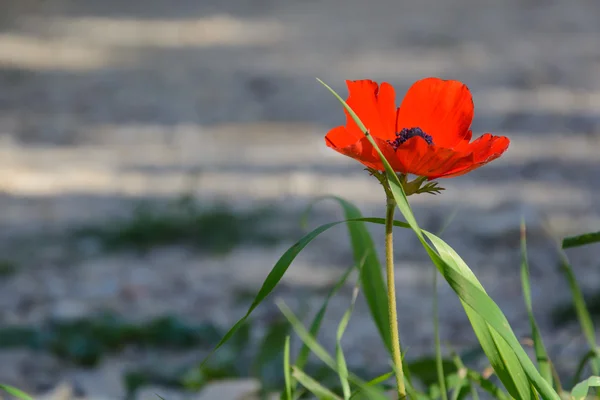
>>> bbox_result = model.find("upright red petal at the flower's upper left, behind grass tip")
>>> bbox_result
[346,80,396,140]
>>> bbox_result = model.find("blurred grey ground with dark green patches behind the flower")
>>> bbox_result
[0,0,600,400]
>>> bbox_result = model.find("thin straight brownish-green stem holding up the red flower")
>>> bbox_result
[385,196,406,399]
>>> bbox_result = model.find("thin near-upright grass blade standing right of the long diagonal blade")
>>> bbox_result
[521,220,553,385]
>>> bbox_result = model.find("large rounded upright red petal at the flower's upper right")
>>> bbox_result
[396,78,474,148]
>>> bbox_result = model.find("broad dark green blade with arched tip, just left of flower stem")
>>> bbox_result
[305,196,392,354]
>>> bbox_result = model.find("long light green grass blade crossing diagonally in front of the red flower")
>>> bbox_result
[319,80,560,400]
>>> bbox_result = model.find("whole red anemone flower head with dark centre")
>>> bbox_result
[325,78,510,180]
